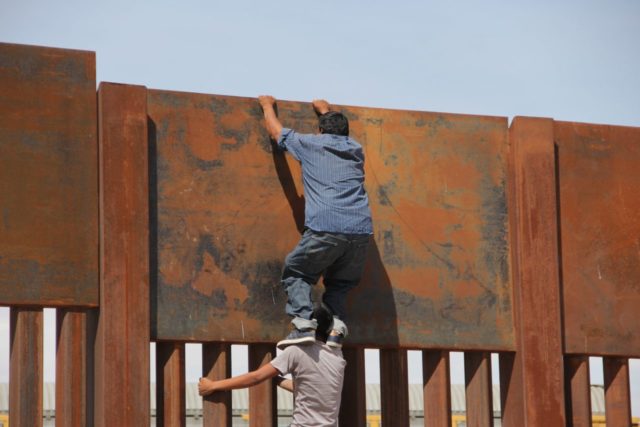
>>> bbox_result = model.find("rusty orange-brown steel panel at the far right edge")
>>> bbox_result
[554,122,640,357]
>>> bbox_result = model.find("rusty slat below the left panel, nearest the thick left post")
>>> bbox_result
[56,309,89,427]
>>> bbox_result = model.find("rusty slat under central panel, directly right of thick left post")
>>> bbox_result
[157,342,187,427]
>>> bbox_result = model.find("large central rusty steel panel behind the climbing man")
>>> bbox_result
[148,90,514,350]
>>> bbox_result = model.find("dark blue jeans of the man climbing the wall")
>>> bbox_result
[282,229,371,336]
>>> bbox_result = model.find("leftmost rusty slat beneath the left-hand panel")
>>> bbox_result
[9,307,43,427]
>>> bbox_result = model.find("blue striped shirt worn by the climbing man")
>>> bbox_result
[278,128,373,234]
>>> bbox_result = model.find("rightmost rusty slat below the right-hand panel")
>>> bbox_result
[602,357,631,426]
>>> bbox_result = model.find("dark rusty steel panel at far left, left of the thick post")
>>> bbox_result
[0,43,98,306]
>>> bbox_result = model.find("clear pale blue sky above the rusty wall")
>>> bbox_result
[0,0,640,416]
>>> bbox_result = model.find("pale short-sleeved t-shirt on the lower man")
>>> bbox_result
[271,341,347,427]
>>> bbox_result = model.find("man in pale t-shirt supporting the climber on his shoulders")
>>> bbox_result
[198,305,346,427]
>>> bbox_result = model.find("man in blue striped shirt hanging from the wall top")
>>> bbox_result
[258,95,373,348]
